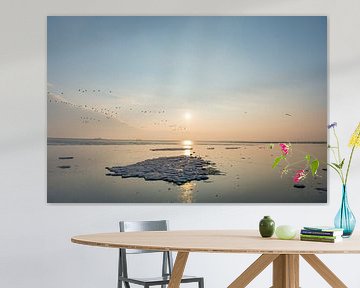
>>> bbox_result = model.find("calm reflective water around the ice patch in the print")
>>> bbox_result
[47,140,327,203]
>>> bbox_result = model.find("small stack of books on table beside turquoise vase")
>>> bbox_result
[300,227,344,243]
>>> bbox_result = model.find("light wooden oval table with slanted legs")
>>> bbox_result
[71,230,360,288]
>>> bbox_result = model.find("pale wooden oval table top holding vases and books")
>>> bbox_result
[71,230,360,254]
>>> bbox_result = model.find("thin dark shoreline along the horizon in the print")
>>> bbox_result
[47,137,327,145]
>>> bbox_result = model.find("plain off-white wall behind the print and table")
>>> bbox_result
[0,0,360,288]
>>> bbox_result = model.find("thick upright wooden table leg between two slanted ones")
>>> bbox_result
[272,254,299,288]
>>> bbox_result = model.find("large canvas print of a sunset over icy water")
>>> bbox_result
[47,16,327,203]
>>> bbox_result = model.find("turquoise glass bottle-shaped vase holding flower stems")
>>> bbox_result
[334,185,356,237]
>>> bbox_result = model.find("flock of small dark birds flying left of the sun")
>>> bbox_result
[48,88,187,131]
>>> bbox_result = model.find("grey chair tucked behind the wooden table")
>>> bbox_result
[118,220,204,288]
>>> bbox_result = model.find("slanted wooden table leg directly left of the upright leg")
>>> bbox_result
[228,254,279,288]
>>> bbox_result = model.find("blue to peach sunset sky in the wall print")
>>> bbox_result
[47,16,327,142]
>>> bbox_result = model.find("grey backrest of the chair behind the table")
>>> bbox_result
[119,220,169,254]
